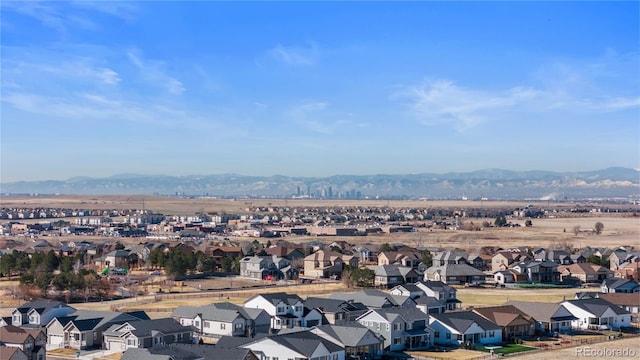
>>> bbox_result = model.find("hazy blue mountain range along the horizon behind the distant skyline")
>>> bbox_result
[0,167,640,200]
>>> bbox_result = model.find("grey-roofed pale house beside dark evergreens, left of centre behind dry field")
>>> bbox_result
[240,255,297,280]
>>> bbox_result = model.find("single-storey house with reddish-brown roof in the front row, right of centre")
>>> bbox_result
[473,305,536,342]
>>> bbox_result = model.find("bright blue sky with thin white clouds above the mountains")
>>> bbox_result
[0,1,640,182]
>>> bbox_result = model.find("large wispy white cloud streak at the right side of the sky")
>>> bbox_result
[398,53,640,131]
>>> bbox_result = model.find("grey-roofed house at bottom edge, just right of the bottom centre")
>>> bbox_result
[310,322,384,359]
